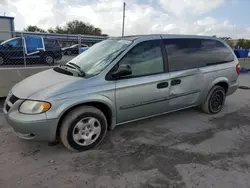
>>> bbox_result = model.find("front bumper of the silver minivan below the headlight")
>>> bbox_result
[3,97,58,142]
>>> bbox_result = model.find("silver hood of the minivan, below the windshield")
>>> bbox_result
[12,69,83,100]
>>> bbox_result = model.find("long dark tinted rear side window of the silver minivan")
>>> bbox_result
[164,39,234,71]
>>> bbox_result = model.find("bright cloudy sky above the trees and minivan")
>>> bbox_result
[0,0,250,38]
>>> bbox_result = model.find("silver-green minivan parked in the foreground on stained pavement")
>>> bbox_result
[4,35,240,151]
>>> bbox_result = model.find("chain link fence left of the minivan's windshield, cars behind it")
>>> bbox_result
[0,31,107,68]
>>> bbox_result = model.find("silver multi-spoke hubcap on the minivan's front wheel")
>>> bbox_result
[73,117,101,146]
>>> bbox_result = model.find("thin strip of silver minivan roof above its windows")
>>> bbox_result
[110,34,223,41]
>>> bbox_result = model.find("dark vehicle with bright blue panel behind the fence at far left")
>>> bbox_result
[0,37,62,65]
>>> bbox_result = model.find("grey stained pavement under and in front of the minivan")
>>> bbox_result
[0,75,250,188]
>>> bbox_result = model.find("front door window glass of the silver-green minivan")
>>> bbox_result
[119,40,164,77]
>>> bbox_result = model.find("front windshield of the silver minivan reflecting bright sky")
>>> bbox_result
[68,39,132,76]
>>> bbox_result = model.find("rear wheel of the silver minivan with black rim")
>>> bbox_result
[201,85,226,114]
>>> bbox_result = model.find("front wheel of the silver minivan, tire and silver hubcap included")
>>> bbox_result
[60,106,108,151]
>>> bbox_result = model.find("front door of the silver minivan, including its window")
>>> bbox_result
[116,40,169,123]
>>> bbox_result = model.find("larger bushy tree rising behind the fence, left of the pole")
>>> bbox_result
[48,20,107,35]
